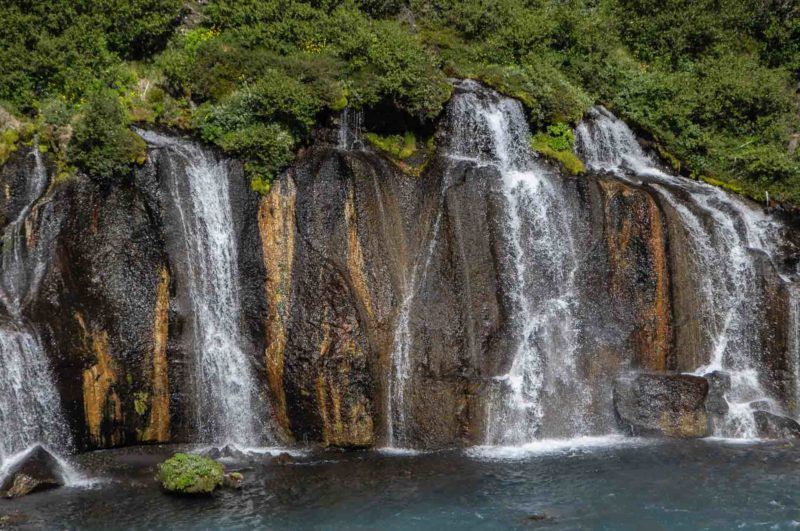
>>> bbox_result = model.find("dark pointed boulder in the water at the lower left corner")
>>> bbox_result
[0,445,64,498]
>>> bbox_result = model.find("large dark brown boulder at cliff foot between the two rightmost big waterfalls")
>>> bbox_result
[614,373,709,438]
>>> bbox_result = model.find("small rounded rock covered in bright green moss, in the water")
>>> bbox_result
[156,454,225,494]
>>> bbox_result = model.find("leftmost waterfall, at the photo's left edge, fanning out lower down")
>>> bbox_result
[0,148,71,462]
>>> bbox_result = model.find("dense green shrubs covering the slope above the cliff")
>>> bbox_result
[0,0,800,205]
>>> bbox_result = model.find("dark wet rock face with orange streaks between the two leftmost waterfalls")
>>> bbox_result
[33,171,170,449]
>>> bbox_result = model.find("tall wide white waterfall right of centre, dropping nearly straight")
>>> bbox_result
[449,82,589,445]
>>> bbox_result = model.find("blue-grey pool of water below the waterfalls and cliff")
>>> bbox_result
[6,439,800,530]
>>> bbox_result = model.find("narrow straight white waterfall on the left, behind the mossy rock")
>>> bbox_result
[138,131,270,445]
